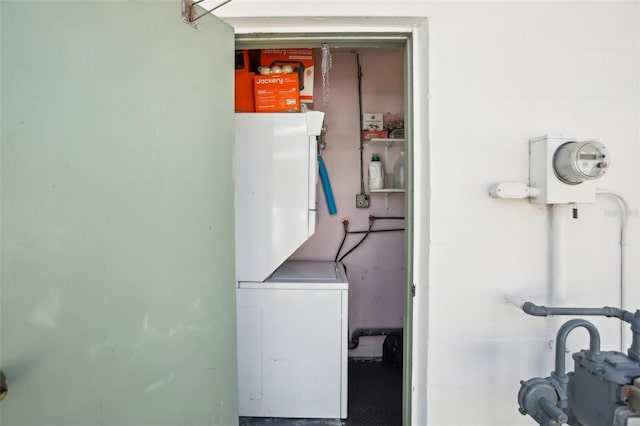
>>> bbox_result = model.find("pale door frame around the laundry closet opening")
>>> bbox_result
[230,17,431,426]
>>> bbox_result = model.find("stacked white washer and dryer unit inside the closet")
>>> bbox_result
[235,111,349,418]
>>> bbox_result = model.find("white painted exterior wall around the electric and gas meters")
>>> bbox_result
[216,0,640,426]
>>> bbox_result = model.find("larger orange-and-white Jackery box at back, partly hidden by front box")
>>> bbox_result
[260,48,314,103]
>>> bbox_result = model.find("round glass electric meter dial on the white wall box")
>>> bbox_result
[553,141,609,185]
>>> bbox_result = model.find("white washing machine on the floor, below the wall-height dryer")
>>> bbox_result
[237,261,349,418]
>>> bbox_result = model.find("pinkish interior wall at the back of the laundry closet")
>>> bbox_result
[292,49,405,356]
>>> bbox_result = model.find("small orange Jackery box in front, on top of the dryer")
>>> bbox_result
[253,73,300,112]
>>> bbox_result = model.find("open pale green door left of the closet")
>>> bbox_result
[0,1,237,426]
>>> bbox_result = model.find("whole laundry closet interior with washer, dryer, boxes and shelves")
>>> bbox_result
[235,44,410,425]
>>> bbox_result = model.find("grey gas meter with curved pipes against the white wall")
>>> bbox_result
[518,302,640,426]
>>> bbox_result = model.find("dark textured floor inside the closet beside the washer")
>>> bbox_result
[240,359,402,426]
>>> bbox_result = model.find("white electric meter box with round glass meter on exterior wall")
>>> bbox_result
[529,135,609,204]
